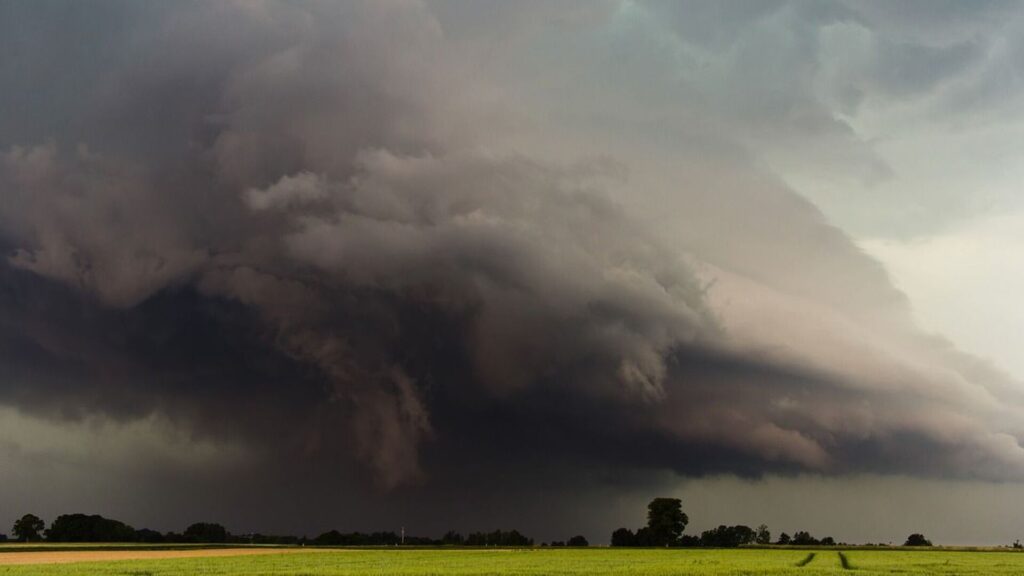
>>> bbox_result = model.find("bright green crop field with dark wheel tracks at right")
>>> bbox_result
[0,548,1024,576]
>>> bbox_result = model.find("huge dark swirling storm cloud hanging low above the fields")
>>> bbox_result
[0,2,1024,524]
